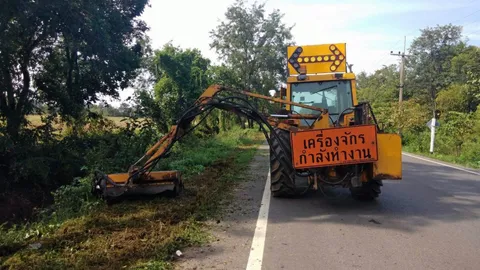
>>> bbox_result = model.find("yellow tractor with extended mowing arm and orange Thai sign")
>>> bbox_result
[93,43,402,200]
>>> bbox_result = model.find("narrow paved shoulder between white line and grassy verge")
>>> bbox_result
[176,144,269,269]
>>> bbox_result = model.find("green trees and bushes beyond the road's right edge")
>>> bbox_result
[358,25,480,168]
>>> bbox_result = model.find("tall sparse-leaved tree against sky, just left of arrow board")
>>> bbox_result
[210,0,292,94]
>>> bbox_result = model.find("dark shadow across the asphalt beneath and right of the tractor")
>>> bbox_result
[269,161,480,231]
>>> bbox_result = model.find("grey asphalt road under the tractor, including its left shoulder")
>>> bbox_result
[181,150,480,270]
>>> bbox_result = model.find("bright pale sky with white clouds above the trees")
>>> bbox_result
[109,0,480,103]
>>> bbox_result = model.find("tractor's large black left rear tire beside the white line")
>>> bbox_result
[270,128,296,197]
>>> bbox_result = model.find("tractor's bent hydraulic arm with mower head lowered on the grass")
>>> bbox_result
[93,85,327,199]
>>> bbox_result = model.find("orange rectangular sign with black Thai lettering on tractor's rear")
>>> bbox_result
[290,125,378,169]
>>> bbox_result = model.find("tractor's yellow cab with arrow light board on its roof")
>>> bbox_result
[285,43,357,127]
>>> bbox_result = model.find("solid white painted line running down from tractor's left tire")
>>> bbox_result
[247,170,270,270]
